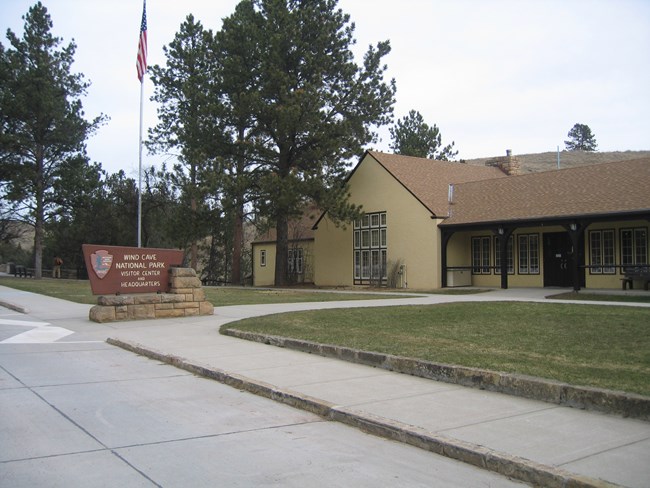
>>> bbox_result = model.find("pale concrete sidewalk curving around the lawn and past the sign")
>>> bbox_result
[0,287,650,487]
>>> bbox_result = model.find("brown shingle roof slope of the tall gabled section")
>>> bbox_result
[368,151,506,217]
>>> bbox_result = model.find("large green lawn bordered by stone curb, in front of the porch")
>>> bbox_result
[227,302,650,395]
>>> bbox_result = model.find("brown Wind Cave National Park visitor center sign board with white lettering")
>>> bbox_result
[81,244,183,295]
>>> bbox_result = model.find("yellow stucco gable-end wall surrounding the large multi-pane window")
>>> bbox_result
[314,156,440,289]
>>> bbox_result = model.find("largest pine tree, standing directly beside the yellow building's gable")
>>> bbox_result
[224,0,395,286]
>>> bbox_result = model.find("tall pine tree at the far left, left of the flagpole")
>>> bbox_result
[0,2,104,278]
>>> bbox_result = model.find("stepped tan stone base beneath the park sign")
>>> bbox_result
[89,268,214,323]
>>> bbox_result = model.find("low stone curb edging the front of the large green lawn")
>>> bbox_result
[220,329,650,421]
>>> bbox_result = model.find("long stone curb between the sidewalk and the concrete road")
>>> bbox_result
[106,338,620,488]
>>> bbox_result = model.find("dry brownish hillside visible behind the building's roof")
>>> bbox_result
[465,151,650,173]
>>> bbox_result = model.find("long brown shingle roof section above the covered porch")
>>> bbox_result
[441,158,650,226]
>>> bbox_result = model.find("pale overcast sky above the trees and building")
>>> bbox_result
[0,0,650,177]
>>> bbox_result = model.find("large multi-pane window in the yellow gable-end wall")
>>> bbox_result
[354,212,388,284]
